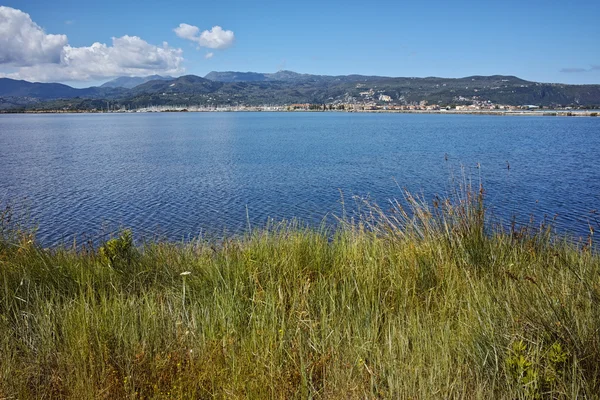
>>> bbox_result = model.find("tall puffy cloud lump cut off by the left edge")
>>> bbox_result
[0,6,67,66]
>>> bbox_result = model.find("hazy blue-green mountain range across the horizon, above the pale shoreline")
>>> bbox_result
[0,71,600,110]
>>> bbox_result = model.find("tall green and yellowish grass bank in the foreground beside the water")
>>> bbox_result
[0,191,600,399]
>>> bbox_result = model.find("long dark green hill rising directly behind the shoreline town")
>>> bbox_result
[117,71,600,107]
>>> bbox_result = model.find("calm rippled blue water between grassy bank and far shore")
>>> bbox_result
[0,113,600,245]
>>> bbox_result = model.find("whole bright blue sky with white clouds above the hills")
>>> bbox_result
[0,0,600,86]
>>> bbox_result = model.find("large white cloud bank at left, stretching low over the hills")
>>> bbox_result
[0,7,183,82]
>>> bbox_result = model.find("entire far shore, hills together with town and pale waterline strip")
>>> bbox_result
[0,71,600,116]
